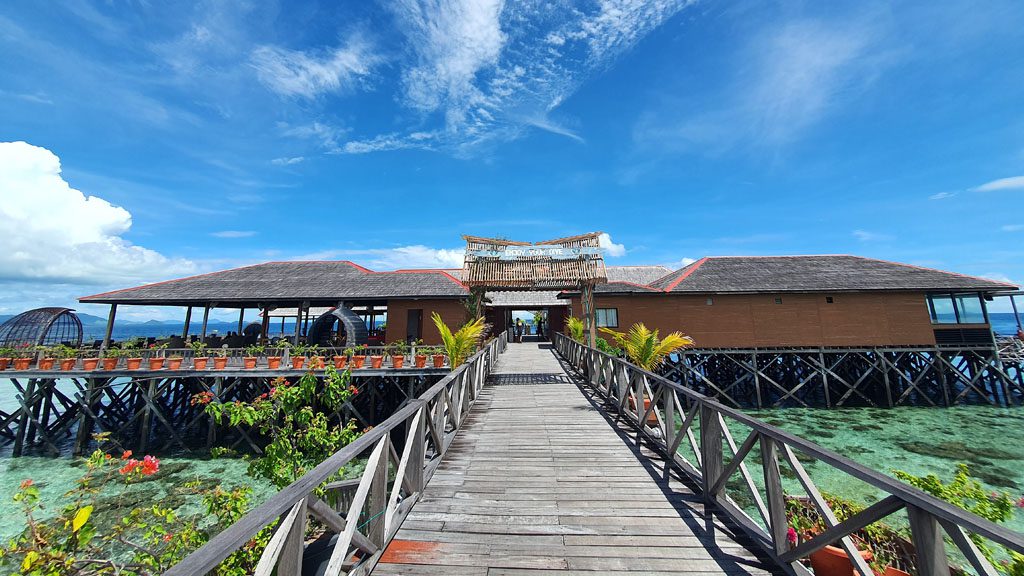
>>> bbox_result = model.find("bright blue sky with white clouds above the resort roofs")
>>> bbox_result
[0,0,1024,315]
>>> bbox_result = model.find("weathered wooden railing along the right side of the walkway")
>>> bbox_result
[553,334,1024,576]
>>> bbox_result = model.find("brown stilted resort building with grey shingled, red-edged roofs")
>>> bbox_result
[80,255,1016,348]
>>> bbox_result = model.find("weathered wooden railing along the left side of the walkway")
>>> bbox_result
[165,334,508,576]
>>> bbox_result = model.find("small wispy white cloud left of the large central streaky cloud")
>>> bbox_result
[252,36,380,98]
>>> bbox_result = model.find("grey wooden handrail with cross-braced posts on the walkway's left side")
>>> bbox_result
[165,333,508,576]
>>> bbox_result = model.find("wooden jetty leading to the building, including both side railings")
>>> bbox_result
[166,334,1024,576]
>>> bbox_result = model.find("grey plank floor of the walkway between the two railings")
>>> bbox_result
[373,343,781,576]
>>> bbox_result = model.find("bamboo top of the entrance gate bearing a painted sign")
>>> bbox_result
[463,232,608,290]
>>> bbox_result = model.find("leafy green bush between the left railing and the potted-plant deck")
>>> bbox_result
[196,365,360,488]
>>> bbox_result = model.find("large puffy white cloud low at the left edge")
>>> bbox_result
[0,141,196,284]
